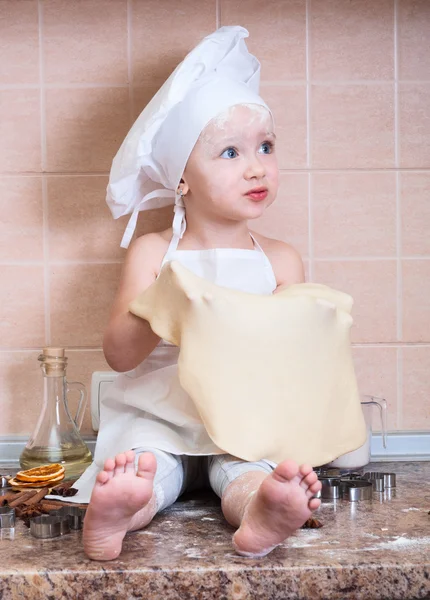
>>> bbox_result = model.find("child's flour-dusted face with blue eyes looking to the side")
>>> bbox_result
[183,105,279,221]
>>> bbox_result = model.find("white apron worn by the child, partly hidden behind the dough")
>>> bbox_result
[67,236,276,502]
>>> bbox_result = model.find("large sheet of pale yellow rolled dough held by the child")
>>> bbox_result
[130,262,366,466]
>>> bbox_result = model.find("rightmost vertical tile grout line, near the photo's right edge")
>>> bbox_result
[393,0,403,428]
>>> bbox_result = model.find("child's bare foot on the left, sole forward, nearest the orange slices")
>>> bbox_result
[83,450,157,560]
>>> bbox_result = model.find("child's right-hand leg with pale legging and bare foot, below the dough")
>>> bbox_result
[209,455,321,557]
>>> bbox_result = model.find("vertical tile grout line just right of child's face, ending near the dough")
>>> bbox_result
[305,0,314,281]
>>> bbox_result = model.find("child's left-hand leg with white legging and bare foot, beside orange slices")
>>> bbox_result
[83,448,184,560]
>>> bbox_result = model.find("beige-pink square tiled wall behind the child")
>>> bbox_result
[0,0,430,435]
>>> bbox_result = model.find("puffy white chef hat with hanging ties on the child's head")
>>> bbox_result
[106,26,270,248]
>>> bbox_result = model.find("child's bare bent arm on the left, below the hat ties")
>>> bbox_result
[103,233,168,372]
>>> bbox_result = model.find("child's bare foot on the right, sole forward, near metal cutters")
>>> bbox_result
[233,460,321,557]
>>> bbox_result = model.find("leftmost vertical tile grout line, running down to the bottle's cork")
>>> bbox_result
[37,0,51,345]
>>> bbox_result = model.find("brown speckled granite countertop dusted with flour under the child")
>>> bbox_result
[0,462,430,600]
